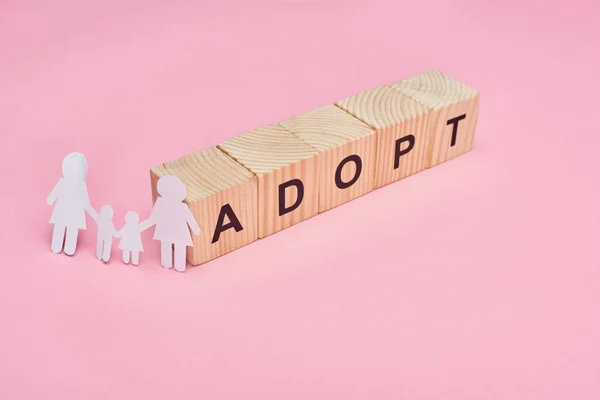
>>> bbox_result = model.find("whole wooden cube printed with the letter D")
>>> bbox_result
[218,124,319,238]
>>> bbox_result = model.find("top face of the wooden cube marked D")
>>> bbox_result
[218,124,318,175]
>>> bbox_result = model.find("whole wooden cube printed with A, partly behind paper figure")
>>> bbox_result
[150,147,258,265]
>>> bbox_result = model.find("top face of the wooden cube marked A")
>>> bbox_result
[151,147,255,203]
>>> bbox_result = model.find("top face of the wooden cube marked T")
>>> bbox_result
[392,71,479,110]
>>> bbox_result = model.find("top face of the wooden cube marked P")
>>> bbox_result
[336,86,427,130]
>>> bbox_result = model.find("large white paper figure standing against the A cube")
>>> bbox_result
[140,175,200,272]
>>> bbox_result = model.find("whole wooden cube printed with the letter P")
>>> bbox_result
[336,86,429,188]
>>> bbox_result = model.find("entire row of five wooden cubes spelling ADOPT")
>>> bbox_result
[151,71,479,265]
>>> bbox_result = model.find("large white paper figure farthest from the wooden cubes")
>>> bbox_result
[46,152,96,255]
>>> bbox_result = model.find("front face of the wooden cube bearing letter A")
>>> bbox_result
[187,178,258,265]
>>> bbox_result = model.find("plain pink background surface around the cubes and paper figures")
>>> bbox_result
[0,0,600,400]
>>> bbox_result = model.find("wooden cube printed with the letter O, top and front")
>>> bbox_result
[280,105,376,212]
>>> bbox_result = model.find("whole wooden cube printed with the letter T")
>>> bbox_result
[392,71,479,167]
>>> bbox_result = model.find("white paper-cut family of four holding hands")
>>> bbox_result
[46,152,200,272]
